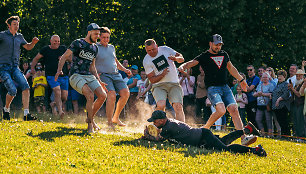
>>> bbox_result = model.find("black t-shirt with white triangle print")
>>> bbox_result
[194,50,230,88]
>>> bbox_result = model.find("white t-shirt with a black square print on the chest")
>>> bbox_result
[143,46,179,84]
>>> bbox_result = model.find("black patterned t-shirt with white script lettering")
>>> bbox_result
[68,39,98,75]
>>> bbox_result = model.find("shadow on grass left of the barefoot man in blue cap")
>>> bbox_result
[27,127,88,142]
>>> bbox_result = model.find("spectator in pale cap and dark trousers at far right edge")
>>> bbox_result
[289,69,305,137]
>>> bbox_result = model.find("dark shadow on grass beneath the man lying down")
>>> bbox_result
[114,139,213,157]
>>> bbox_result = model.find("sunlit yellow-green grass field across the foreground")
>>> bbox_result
[0,115,306,173]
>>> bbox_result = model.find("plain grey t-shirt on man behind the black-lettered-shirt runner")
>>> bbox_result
[96,44,118,74]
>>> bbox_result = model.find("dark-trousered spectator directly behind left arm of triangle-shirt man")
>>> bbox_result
[196,66,211,123]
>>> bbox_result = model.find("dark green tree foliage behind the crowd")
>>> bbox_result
[0,0,306,71]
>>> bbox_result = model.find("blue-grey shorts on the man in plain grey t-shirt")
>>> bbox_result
[100,73,128,92]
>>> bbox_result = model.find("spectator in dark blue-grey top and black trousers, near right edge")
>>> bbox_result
[272,70,291,135]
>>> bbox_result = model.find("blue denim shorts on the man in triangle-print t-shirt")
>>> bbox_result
[207,85,237,107]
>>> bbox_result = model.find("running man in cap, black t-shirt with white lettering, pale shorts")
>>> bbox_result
[54,23,107,133]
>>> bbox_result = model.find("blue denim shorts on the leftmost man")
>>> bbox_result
[0,64,30,96]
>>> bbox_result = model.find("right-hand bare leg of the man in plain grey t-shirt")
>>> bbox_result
[112,88,130,126]
